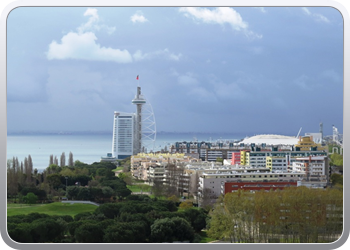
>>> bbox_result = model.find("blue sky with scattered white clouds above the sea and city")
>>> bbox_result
[7,7,344,135]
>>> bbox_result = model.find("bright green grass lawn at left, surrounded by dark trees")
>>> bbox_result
[7,202,97,216]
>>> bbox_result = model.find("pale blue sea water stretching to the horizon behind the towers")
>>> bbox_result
[6,133,241,172]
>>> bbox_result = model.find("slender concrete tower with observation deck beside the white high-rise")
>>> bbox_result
[132,87,146,154]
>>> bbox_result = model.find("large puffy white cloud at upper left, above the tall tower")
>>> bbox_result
[47,32,132,63]
